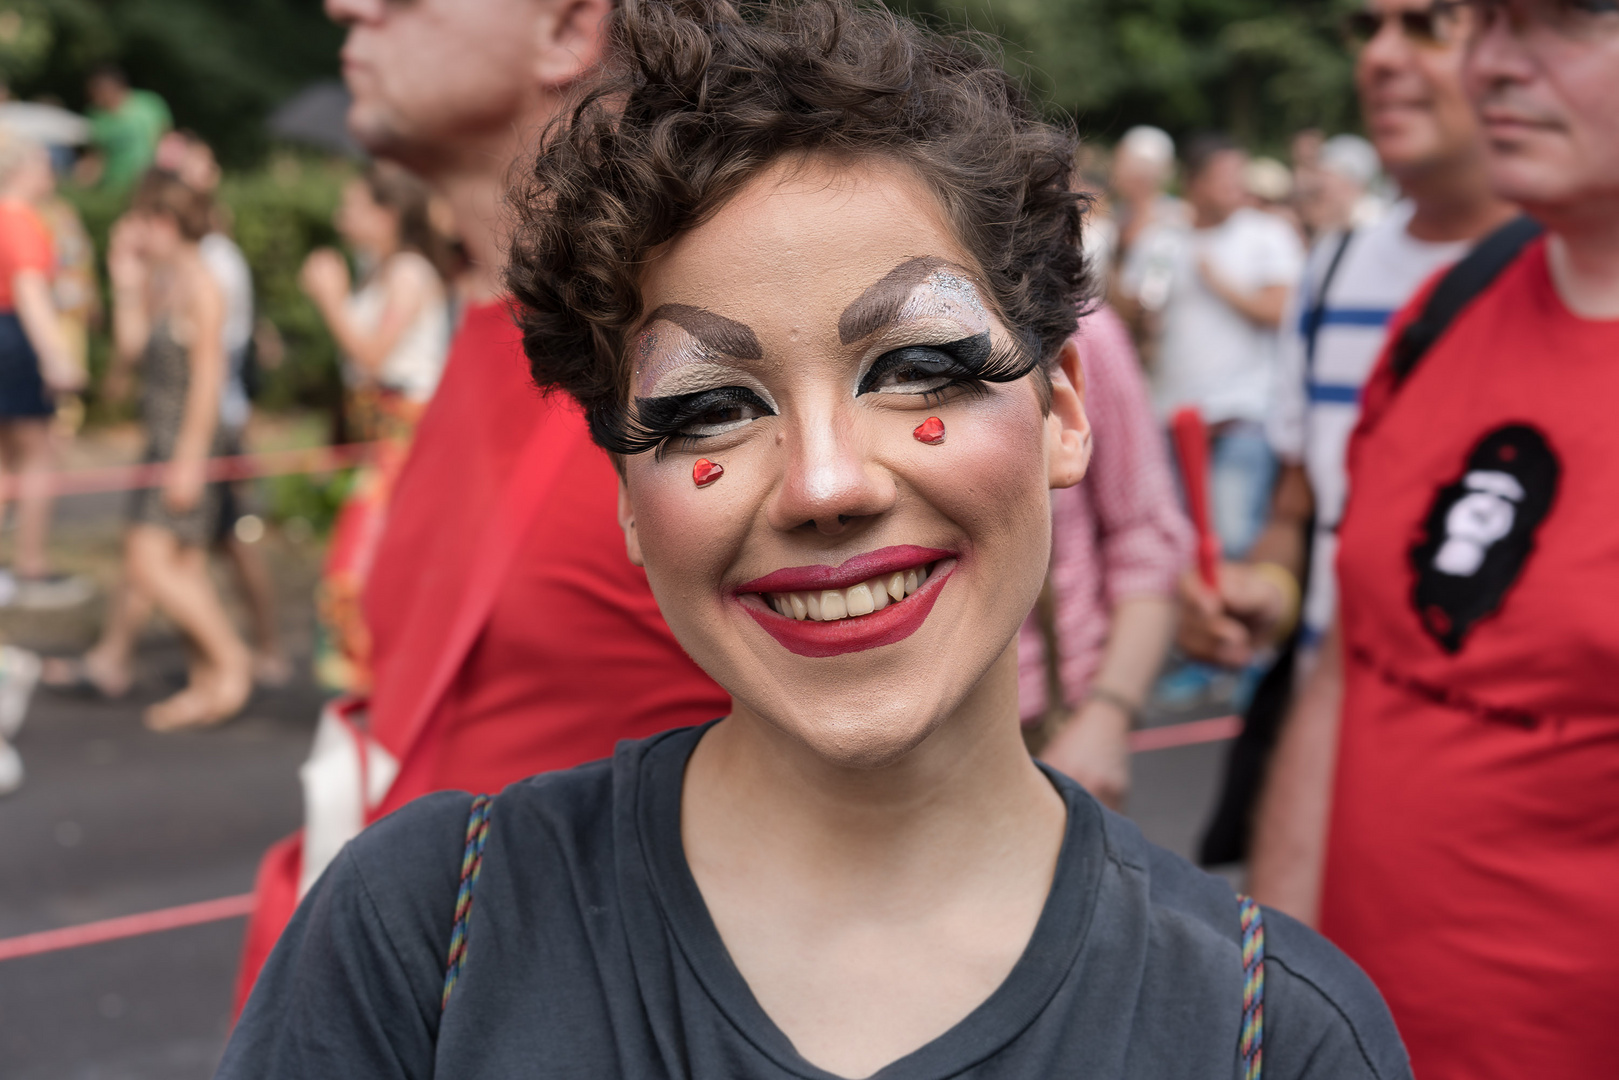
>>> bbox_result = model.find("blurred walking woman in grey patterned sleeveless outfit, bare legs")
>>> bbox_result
[45,172,253,730]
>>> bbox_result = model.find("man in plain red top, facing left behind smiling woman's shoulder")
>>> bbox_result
[238,0,730,1006]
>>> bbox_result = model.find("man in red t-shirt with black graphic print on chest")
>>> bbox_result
[1251,0,1619,1080]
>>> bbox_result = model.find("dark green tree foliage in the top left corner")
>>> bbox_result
[0,0,343,165]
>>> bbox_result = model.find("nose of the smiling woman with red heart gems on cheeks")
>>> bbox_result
[769,418,895,536]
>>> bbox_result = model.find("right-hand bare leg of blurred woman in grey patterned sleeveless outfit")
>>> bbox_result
[126,525,253,730]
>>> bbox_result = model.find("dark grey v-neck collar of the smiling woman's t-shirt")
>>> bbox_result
[635,724,1106,1080]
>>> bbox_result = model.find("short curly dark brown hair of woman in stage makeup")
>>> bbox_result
[507,0,1088,449]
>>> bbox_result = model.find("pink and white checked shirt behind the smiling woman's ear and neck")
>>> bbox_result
[1017,308,1193,724]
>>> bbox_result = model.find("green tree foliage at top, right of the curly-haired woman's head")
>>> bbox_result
[903,0,1358,149]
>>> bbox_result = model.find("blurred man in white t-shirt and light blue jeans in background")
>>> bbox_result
[1124,134,1303,557]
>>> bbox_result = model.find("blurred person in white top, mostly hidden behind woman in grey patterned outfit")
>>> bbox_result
[156,131,291,687]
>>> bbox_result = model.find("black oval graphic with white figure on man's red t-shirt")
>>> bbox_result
[1410,424,1562,653]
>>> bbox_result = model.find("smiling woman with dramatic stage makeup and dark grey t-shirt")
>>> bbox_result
[220,0,1409,1080]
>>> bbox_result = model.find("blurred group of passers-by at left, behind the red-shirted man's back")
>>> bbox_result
[0,68,460,790]
